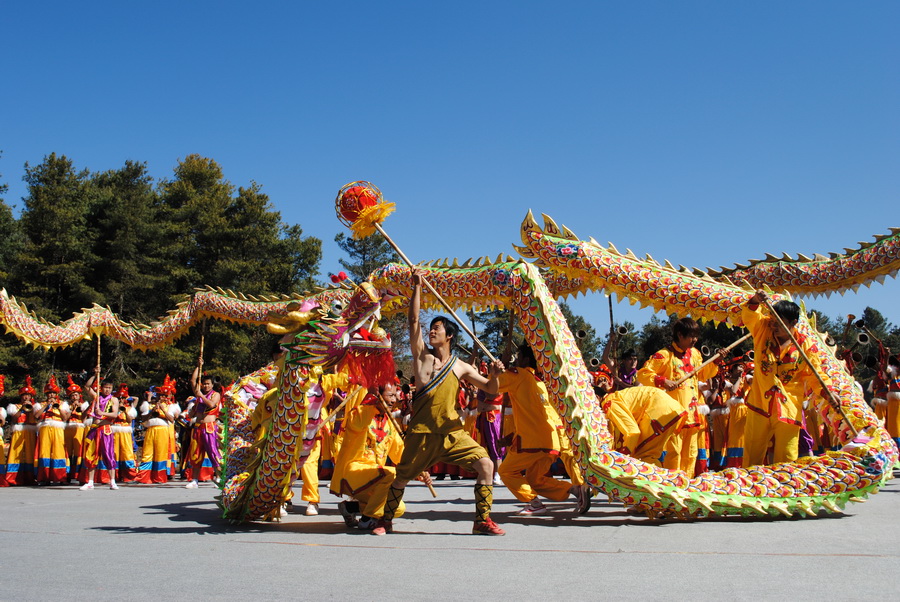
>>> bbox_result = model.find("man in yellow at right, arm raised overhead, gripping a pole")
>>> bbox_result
[741,291,830,466]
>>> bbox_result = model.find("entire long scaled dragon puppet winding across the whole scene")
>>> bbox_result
[0,213,900,520]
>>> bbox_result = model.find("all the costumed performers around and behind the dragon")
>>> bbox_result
[0,284,900,535]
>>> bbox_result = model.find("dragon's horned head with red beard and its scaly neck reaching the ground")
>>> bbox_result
[221,282,394,521]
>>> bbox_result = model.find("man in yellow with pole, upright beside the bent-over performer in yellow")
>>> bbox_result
[637,318,719,477]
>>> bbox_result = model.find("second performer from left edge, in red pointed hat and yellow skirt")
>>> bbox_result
[35,374,70,484]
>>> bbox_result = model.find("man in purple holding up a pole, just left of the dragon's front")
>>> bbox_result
[185,356,222,489]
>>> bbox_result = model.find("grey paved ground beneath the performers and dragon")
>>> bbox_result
[0,474,900,600]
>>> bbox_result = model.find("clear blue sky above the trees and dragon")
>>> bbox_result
[0,1,900,330]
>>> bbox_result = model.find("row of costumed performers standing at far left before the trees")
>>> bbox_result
[0,361,222,491]
